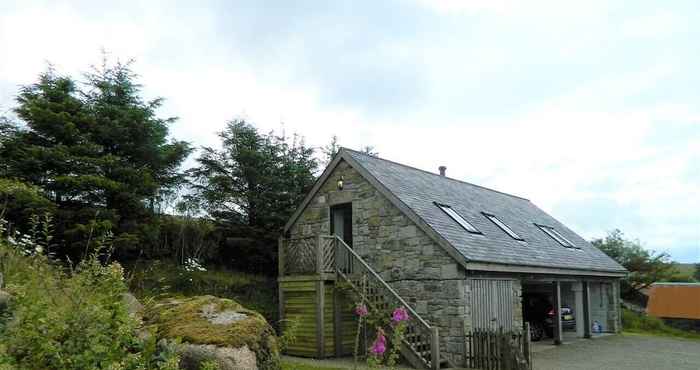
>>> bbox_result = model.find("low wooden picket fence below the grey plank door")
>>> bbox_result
[465,324,532,370]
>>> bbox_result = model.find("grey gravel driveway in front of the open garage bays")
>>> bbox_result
[532,334,700,370]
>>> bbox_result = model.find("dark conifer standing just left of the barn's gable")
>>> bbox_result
[190,120,318,273]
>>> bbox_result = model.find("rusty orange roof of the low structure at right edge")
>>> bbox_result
[647,283,700,320]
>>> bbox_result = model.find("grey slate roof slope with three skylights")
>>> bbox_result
[342,148,626,273]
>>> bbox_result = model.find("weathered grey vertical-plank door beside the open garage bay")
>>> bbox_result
[471,279,515,331]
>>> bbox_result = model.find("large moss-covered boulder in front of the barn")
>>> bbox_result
[145,296,280,370]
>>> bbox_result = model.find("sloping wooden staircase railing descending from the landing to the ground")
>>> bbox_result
[332,237,440,369]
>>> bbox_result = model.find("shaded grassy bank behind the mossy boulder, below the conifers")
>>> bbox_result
[126,260,278,326]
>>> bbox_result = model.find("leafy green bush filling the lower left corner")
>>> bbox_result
[0,233,177,369]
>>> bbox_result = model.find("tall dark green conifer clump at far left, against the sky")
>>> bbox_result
[0,62,191,256]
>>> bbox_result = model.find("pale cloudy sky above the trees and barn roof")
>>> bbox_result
[0,0,700,262]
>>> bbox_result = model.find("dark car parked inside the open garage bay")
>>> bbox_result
[523,294,576,341]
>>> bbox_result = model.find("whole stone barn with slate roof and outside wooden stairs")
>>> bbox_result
[279,148,626,369]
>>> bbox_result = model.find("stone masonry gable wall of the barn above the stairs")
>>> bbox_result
[291,161,469,364]
